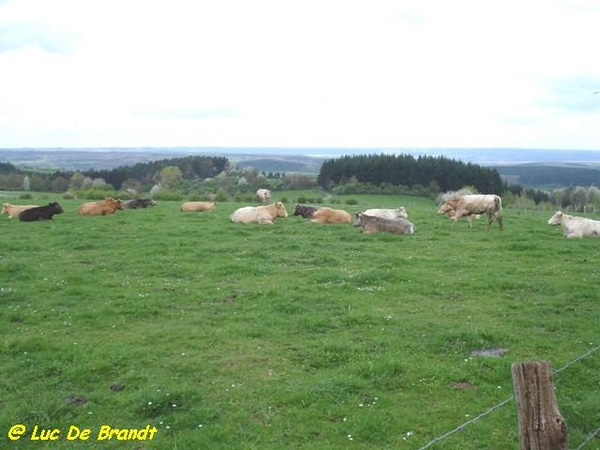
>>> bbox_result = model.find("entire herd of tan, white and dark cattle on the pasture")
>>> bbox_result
[2,189,600,238]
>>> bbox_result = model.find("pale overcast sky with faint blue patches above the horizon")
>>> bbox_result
[0,0,600,150]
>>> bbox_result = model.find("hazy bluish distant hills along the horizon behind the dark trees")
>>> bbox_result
[0,147,600,188]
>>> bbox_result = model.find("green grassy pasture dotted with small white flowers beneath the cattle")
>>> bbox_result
[0,192,600,450]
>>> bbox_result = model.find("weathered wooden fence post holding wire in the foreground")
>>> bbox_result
[511,361,569,450]
